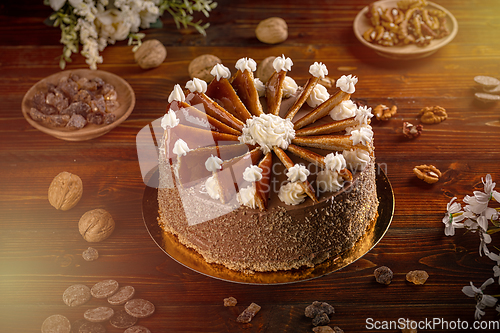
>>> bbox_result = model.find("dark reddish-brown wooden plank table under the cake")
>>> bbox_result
[0,0,500,333]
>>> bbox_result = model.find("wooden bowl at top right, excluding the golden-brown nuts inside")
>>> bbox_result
[354,0,458,60]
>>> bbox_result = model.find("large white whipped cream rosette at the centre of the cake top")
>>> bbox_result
[238,114,295,154]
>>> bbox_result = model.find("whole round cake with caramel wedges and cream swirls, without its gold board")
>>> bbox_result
[158,56,378,272]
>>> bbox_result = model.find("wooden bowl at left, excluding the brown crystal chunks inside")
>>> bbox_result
[22,69,135,141]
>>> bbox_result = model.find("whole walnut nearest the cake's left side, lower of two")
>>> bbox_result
[78,208,115,243]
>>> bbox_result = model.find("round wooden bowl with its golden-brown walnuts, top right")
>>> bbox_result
[353,0,458,60]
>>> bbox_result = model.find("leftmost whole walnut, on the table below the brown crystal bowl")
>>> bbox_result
[49,171,83,210]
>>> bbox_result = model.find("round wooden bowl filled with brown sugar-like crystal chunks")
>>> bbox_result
[22,69,135,141]
